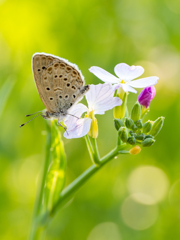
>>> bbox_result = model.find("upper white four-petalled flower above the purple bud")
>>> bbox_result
[89,63,159,93]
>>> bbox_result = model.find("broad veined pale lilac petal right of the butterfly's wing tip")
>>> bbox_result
[86,83,122,114]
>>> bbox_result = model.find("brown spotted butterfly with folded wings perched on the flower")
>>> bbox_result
[20,53,90,127]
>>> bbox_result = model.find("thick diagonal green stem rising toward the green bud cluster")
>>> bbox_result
[50,145,120,216]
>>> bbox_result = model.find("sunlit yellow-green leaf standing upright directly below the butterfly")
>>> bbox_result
[44,121,66,210]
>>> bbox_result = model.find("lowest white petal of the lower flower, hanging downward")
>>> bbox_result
[64,118,92,139]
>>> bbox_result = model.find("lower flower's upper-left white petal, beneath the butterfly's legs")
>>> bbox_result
[64,103,88,129]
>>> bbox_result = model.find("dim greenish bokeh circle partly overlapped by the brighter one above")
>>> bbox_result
[120,195,158,230]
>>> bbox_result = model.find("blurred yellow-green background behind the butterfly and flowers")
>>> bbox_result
[0,0,180,240]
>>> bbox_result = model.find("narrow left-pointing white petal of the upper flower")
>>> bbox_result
[89,66,119,83]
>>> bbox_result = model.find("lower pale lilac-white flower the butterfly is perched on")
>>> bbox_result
[64,83,122,138]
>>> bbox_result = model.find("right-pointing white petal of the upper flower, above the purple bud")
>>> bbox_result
[129,76,159,88]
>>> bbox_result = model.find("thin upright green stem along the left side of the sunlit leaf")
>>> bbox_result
[29,122,51,240]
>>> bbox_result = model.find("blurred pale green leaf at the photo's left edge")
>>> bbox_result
[0,79,14,117]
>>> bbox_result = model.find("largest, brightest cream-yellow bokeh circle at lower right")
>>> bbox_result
[128,166,169,204]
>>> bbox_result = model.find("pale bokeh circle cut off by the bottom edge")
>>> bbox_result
[87,222,121,240]
